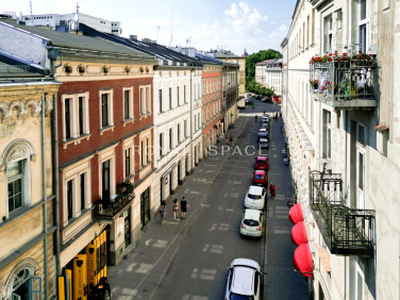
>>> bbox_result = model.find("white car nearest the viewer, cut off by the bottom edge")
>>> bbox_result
[225,258,263,300]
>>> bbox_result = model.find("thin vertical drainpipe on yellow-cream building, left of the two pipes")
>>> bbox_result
[41,94,48,299]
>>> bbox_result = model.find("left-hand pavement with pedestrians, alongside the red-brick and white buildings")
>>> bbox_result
[109,117,245,300]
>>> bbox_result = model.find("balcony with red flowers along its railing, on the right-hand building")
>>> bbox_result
[310,53,377,110]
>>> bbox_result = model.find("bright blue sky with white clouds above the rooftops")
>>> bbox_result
[0,0,296,55]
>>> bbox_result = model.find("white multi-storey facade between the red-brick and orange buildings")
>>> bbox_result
[153,65,202,204]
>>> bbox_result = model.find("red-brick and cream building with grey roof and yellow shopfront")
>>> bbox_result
[0,20,156,298]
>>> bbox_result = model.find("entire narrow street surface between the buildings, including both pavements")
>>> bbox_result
[110,101,308,300]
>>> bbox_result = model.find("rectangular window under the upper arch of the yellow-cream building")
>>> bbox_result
[7,160,24,213]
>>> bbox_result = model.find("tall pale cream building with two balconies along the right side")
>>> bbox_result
[282,0,400,299]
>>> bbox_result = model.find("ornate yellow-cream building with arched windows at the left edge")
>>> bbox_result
[0,51,60,299]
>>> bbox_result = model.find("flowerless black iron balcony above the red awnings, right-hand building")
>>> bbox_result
[310,171,375,257]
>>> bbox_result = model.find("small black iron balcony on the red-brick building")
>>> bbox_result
[94,182,135,220]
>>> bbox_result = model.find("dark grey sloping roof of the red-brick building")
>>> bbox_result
[0,19,155,60]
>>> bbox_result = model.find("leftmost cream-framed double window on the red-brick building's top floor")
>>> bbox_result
[61,92,89,142]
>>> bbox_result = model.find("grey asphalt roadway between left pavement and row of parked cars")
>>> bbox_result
[152,101,275,300]
